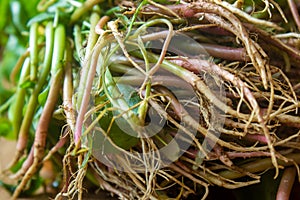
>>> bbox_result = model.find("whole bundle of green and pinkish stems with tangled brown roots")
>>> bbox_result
[0,0,300,199]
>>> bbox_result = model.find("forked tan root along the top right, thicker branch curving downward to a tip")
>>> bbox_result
[142,1,270,89]
